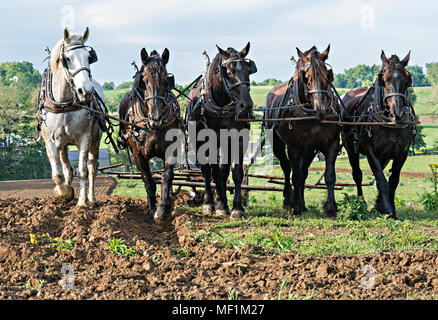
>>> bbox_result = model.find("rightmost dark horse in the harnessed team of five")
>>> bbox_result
[342,50,416,218]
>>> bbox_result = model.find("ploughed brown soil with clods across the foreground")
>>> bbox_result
[0,197,438,299]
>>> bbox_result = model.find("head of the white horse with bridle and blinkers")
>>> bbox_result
[55,27,97,102]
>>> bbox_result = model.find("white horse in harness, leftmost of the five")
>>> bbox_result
[40,27,104,206]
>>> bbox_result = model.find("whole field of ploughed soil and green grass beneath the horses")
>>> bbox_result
[0,87,438,300]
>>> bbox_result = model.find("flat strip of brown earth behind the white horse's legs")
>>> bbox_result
[0,175,117,199]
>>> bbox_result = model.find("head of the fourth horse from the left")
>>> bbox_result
[294,45,333,117]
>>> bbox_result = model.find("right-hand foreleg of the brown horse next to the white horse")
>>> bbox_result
[154,160,175,224]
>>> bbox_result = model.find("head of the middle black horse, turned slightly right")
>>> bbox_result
[213,42,257,114]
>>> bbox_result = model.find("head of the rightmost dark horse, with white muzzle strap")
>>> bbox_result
[378,50,412,121]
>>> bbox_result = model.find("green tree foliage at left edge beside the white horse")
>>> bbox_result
[0,62,50,180]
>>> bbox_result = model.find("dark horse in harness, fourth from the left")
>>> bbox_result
[264,45,341,216]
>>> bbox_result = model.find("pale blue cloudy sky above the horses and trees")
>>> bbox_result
[0,0,438,85]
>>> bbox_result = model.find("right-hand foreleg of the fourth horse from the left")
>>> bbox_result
[324,139,339,217]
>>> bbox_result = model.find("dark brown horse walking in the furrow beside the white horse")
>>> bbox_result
[119,48,183,224]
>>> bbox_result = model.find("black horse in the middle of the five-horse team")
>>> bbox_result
[187,42,257,219]
